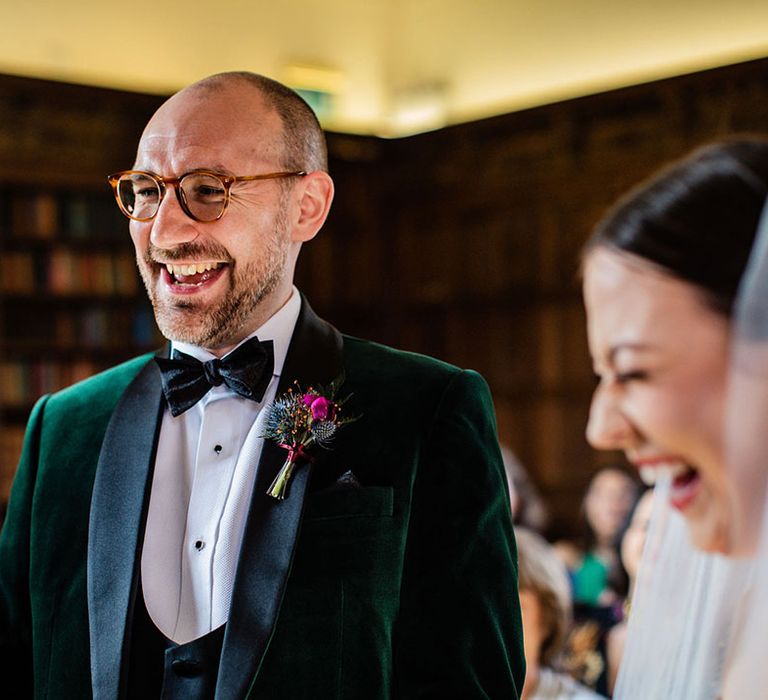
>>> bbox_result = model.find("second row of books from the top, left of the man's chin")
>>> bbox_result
[0,247,139,297]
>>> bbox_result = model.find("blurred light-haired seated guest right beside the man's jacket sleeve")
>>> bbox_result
[515,527,604,700]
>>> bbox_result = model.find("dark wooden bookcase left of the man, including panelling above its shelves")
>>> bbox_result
[0,75,161,504]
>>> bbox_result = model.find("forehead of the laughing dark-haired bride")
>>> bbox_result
[584,249,727,358]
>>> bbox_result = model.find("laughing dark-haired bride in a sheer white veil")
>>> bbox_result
[583,138,768,700]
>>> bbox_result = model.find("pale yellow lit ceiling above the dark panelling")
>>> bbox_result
[0,0,768,136]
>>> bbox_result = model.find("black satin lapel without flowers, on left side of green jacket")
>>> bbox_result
[88,361,164,700]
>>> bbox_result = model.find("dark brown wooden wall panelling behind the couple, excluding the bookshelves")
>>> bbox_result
[0,59,768,534]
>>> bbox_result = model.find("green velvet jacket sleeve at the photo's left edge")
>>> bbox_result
[0,396,48,697]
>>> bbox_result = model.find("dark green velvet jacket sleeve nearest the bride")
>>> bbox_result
[395,371,525,700]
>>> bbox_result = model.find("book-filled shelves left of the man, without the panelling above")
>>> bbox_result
[0,184,160,499]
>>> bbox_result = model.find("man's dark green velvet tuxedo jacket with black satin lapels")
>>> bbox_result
[0,300,524,700]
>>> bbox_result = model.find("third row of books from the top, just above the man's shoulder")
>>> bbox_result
[5,304,160,354]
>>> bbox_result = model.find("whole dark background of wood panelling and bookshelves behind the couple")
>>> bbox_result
[0,59,768,536]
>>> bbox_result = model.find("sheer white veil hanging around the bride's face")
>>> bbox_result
[614,198,768,700]
